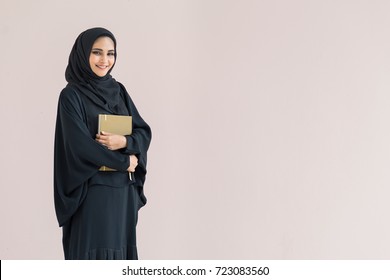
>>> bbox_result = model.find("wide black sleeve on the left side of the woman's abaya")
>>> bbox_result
[54,88,129,226]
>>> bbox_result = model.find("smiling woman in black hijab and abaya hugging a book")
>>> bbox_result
[54,28,151,259]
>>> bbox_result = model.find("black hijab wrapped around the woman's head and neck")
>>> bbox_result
[65,27,124,114]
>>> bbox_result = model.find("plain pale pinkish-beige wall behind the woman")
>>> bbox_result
[0,0,390,259]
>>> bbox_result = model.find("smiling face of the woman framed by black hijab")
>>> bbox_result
[89,37,115,77]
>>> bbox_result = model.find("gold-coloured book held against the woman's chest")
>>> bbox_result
[98,114,133,171]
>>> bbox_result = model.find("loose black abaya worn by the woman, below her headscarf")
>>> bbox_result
[54,85,151,259]
